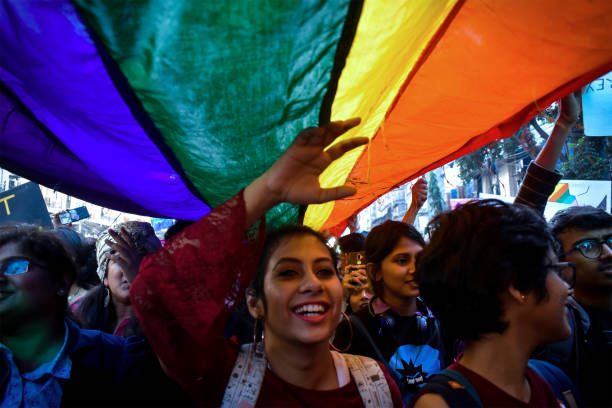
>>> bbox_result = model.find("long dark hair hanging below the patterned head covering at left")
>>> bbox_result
[76,285,144,337]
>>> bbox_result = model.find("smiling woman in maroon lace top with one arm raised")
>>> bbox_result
[130,120,403,407]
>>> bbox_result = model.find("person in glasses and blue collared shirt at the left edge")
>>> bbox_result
[0,225,190,408]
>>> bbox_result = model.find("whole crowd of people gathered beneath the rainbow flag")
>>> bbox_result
[0,91,612,408]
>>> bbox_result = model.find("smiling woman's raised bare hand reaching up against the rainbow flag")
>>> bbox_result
[244,118,368,225]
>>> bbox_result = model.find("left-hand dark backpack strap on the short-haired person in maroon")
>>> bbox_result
[413,368,483,408]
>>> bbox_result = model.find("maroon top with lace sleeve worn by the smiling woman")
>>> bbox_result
[130,193,403,407]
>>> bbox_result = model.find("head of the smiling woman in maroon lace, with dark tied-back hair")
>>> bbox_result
[248,226,342,350]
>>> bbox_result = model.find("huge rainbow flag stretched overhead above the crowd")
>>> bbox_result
[0,0,612,232]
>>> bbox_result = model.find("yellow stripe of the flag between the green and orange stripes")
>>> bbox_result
[304,0,458,230]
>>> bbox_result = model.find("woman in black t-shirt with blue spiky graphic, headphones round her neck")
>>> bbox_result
[333,221,446,402]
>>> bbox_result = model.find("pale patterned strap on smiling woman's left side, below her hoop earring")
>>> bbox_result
[221,342,267,408]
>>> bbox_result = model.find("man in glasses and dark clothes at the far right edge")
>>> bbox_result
[550,206,612,407]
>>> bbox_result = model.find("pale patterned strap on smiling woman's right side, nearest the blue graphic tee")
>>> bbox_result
[342,351,393,408]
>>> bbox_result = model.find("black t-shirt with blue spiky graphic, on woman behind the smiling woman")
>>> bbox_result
[333,301,446,402]
